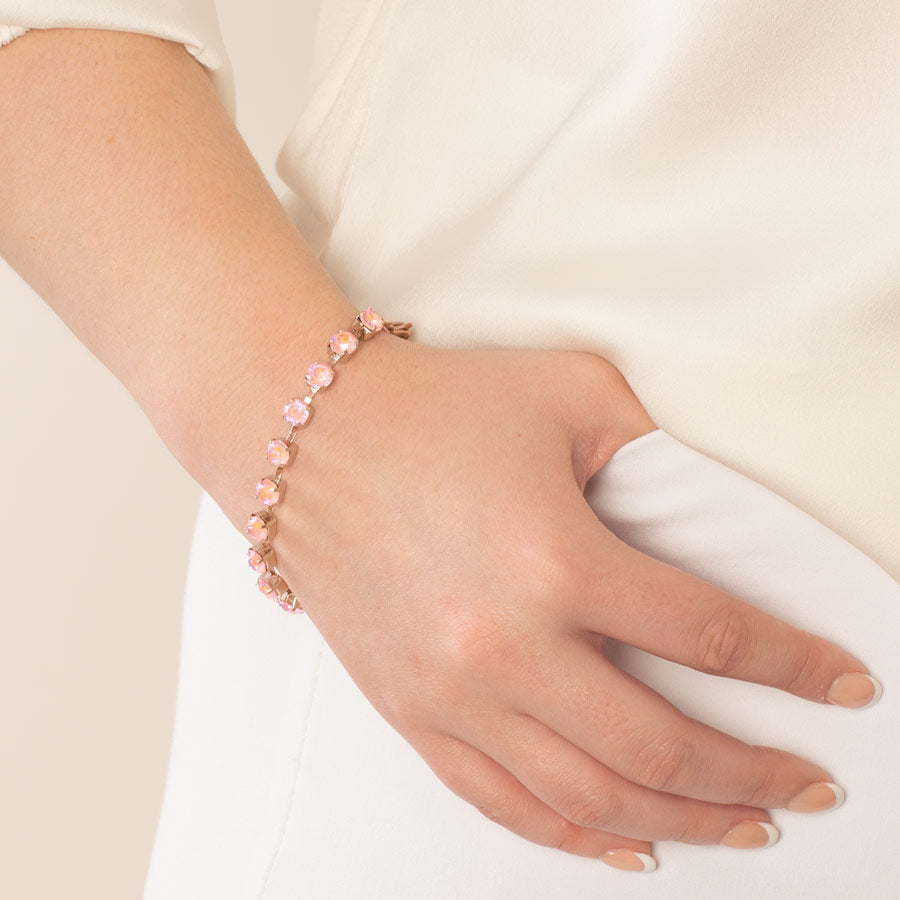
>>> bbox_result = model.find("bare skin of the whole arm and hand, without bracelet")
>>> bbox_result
[0,29,866,857]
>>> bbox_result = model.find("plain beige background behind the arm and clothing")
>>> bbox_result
[0,0,315,900]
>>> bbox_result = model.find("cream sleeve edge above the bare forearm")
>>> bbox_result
[0,0,235,119]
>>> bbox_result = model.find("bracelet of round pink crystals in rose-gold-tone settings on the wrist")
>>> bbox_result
[247,308,412,613]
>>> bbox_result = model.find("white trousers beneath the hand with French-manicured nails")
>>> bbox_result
[144,430,900,900]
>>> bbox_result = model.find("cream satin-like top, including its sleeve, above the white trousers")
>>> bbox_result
[0,0,900,576]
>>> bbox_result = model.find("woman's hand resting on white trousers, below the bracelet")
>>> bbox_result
[275,337,865,859]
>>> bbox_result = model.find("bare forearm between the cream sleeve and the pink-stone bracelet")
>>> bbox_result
[0,28,405,524]
